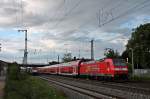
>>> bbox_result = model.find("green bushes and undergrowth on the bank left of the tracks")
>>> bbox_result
[4,64,65,99]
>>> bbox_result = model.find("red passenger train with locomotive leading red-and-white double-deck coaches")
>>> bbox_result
[32,58,128,79]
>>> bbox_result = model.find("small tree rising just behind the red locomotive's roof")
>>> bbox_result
[104,48,120,58]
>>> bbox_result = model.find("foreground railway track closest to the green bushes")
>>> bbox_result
[39,76,120,99]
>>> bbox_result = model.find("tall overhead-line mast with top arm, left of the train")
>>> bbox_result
[18,30,28,66]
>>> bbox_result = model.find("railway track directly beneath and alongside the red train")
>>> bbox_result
[44,75,150,95]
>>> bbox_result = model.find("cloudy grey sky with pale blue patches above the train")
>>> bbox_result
[0,0,150,64]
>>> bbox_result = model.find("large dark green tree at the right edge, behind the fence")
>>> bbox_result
[122,23,150,68]
